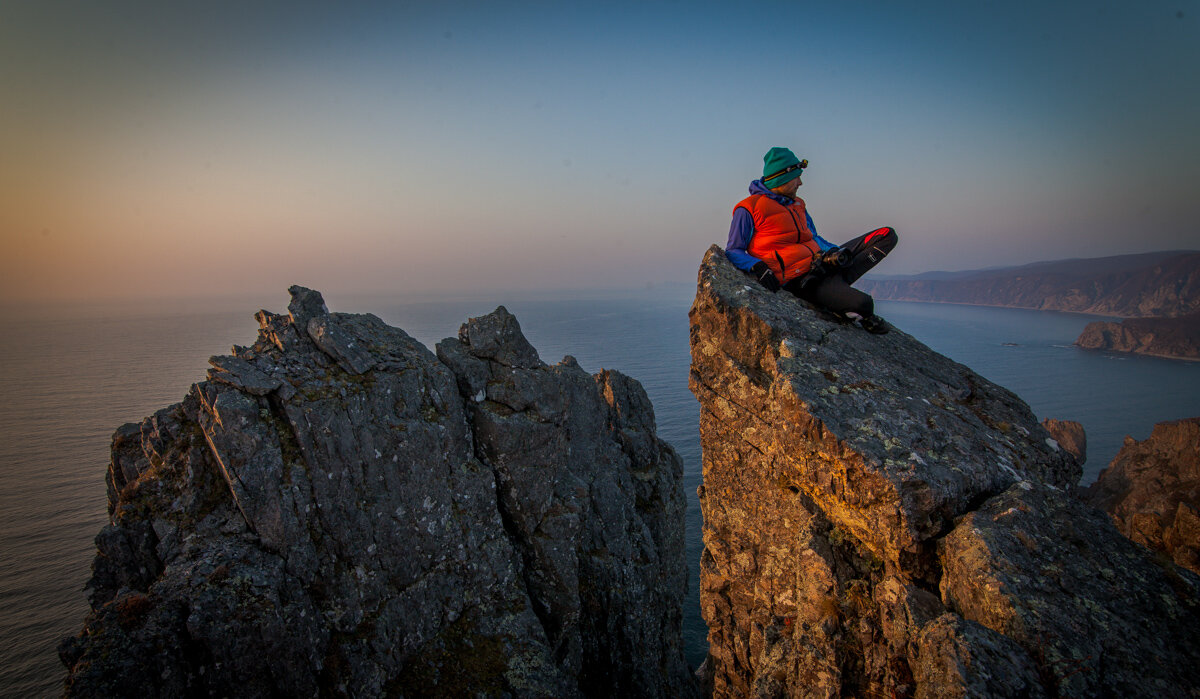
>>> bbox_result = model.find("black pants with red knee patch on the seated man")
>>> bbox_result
[784,228,898,318]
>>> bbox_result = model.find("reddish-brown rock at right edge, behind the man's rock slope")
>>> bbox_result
[1084,418,1200,573]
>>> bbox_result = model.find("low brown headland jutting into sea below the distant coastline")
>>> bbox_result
[1075,313,1200,360]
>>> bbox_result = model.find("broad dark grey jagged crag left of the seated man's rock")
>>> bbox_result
[60,287,696,698]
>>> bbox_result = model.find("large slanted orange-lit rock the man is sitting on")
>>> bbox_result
[691,246,1200,697]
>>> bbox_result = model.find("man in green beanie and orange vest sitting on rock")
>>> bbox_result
[725,147,896,334]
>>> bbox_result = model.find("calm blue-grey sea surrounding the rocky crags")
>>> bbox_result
[0,289,1200,697]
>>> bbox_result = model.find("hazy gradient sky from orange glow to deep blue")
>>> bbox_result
[0,0,1200,301]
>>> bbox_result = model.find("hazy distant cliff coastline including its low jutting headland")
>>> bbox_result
[858,250,1200,359]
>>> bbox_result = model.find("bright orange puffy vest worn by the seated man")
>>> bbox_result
[733,195,821,283]
